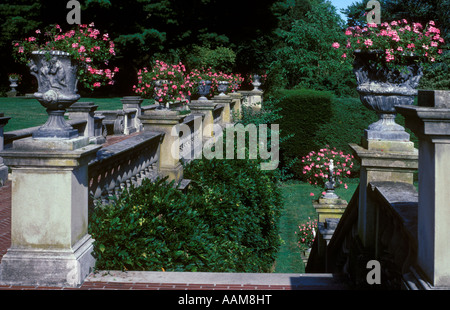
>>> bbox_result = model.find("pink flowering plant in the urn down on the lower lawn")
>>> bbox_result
[302,146,354,189]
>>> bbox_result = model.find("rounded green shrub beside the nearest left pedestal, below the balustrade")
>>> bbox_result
[89,179,213,271]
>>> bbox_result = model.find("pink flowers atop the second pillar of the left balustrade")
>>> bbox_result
[133,60,190,103]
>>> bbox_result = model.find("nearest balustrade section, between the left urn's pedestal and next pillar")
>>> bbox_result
[88,132,164,207]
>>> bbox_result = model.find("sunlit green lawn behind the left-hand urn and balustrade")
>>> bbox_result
[0,97,155,131]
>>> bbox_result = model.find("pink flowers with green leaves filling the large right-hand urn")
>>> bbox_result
[332,19,444,67]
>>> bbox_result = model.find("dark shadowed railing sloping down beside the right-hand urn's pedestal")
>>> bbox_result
[307,182,418,289]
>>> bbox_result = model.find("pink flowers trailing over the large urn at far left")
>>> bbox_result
[13,23,119,90]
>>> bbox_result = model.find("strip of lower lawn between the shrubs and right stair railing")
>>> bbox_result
[275,179,359,273]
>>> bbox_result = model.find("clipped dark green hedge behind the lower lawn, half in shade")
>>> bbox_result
[275,89,377,178]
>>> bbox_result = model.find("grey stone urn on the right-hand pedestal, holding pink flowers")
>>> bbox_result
[353,51,423,141]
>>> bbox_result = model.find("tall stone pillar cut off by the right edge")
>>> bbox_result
[396,91,450,287]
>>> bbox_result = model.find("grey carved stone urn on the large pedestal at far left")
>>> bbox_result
[28,51,80,139]
